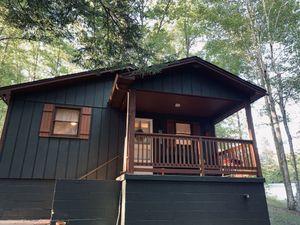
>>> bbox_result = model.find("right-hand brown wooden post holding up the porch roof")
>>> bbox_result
[245,103,262,177]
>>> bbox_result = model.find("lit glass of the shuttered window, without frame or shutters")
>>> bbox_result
[53,108,80,136]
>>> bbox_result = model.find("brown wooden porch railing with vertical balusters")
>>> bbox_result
[131,133,257,176]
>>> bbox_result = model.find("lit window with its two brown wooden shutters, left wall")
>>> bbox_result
[40,104,92,139]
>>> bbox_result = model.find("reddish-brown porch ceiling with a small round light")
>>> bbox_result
[136,90,242,122]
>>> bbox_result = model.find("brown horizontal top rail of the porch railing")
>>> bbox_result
[136,132,252,143]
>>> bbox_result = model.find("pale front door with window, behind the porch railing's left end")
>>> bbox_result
[134,118,153,174]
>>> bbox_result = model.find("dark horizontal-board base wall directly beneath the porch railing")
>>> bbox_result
[122,175,270,225]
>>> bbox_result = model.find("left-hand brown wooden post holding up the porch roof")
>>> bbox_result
[124,90,136,173]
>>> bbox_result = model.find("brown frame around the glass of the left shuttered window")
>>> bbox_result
[50,105,82,138]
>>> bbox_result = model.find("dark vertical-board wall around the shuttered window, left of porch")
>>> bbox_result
[0,79,125,179]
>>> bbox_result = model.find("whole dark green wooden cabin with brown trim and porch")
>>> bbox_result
[0,57,270,225]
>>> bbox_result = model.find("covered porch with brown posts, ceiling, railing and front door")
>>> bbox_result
[118,90,261,177]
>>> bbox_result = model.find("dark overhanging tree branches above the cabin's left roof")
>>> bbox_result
[1,0,143,69]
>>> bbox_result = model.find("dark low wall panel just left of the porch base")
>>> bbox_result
[51,180,121,225]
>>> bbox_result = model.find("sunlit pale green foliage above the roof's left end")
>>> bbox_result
[0,3,78,86]
